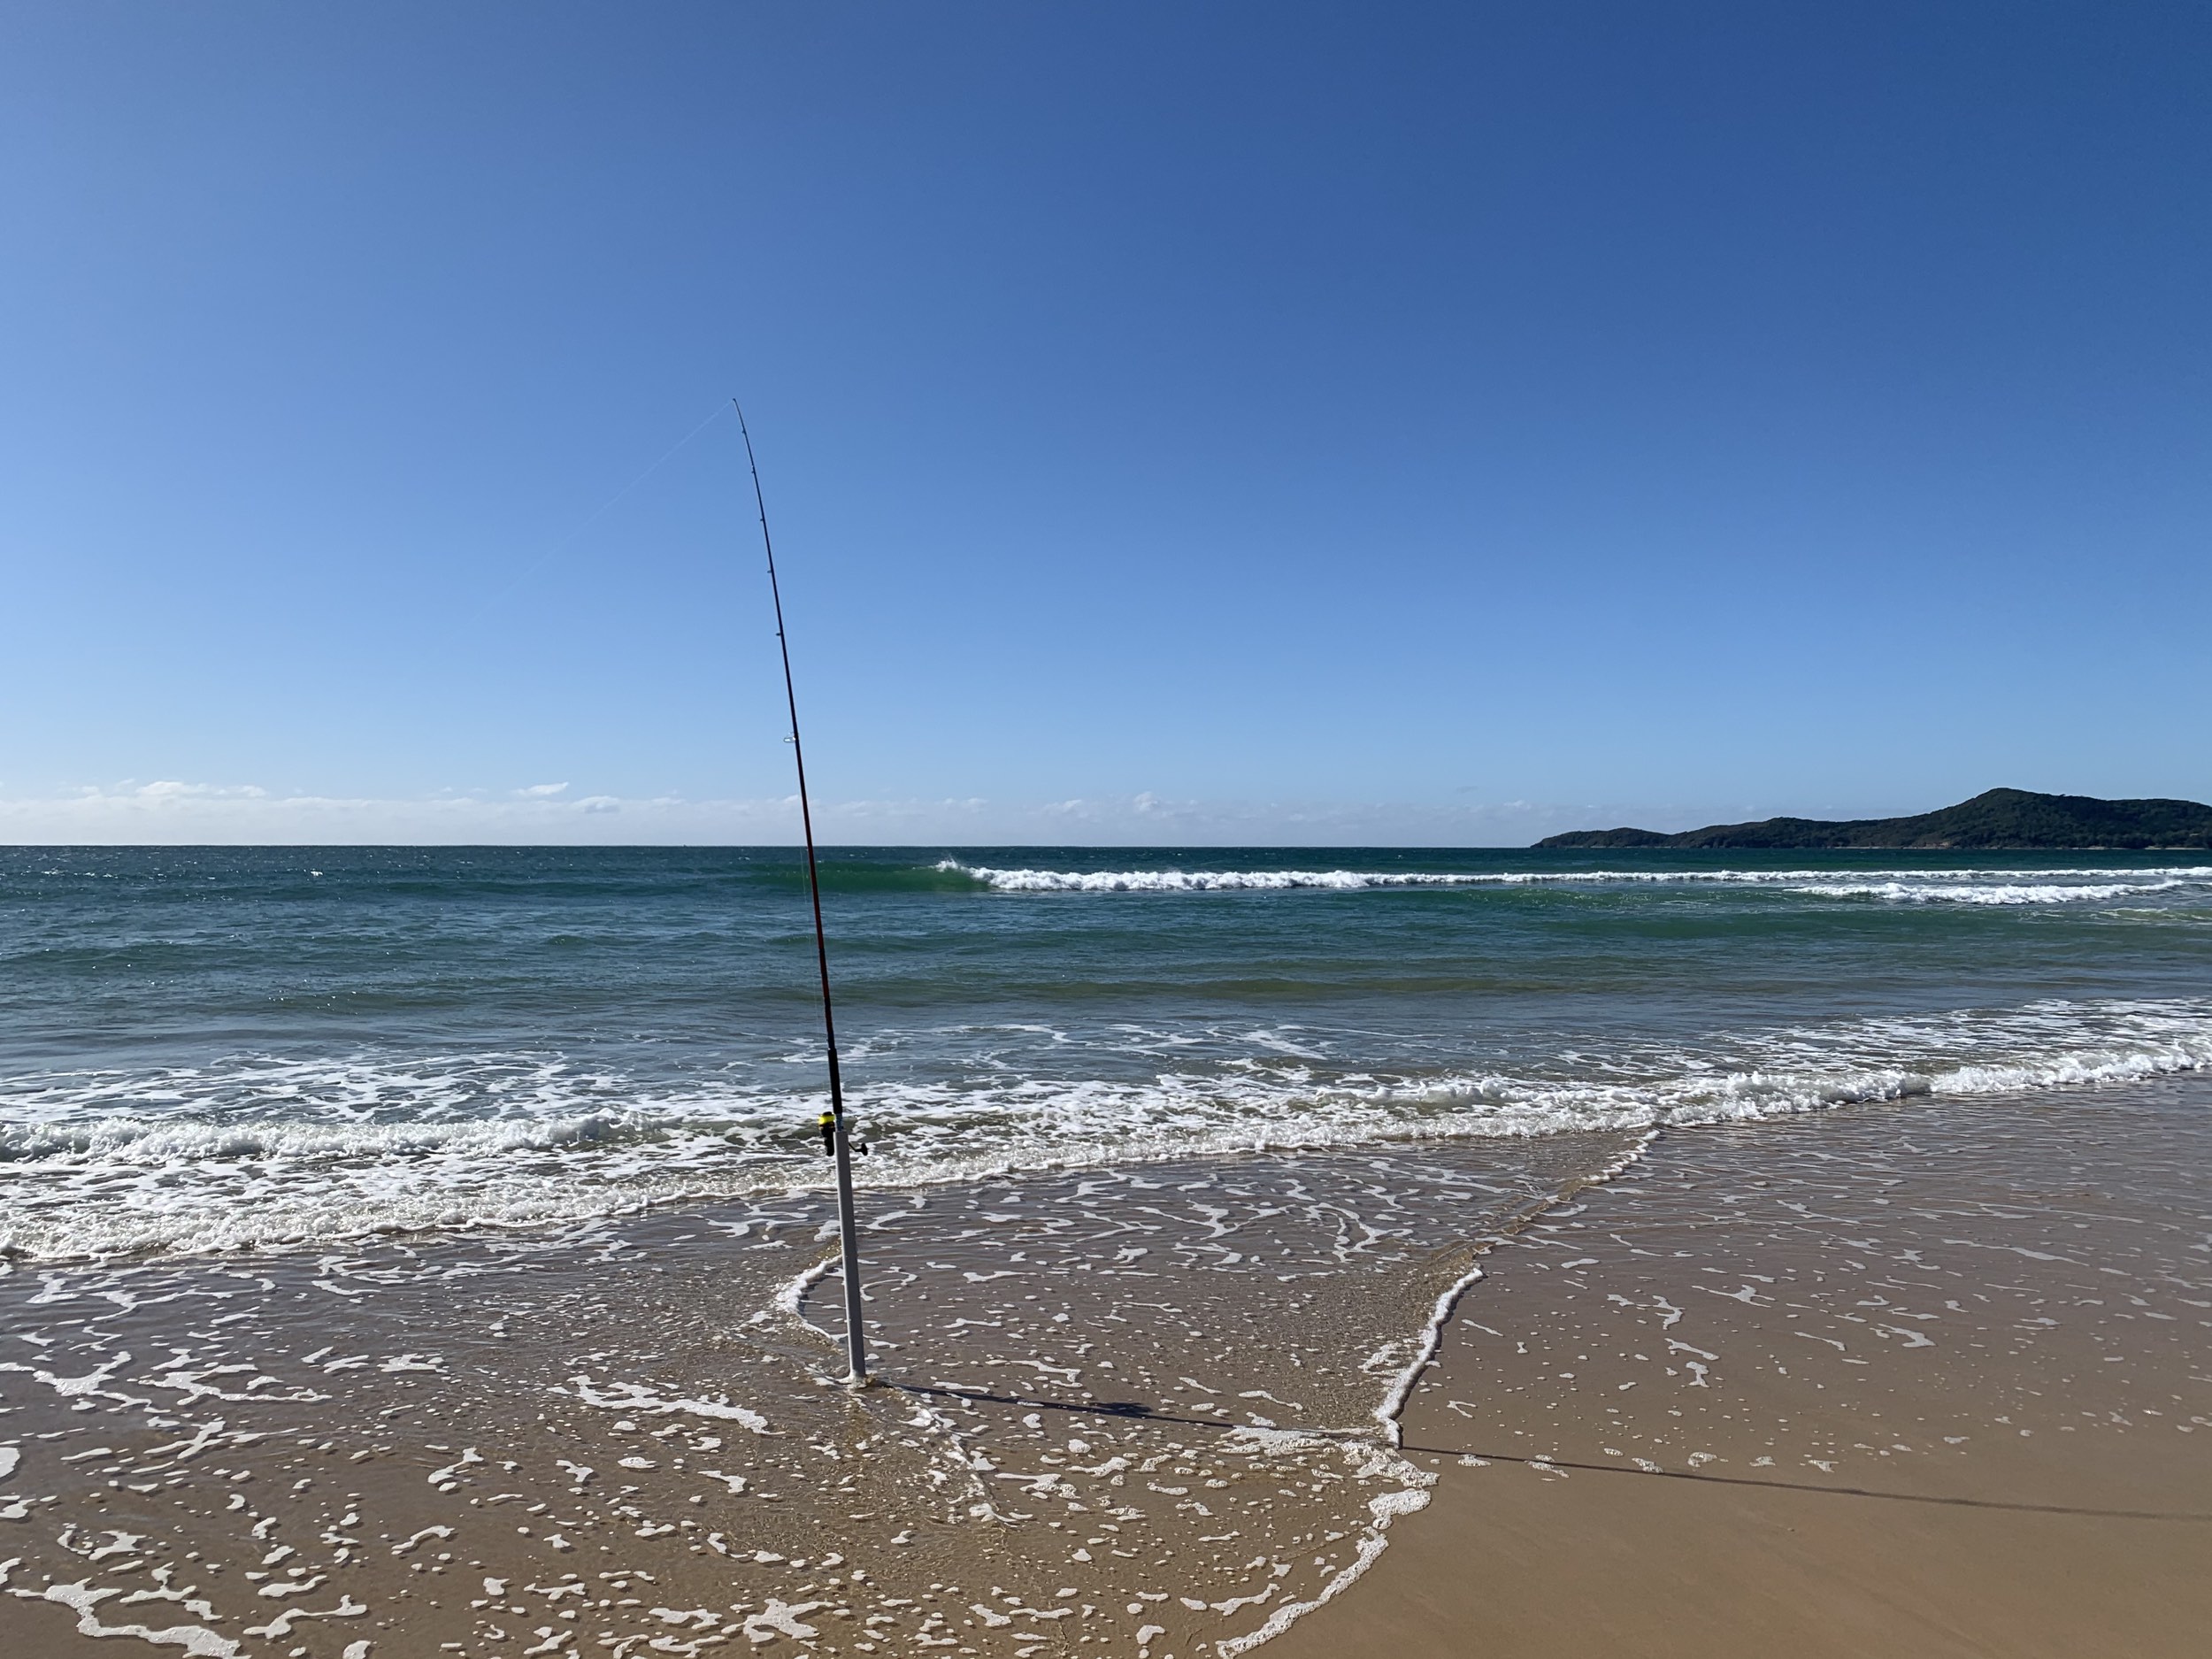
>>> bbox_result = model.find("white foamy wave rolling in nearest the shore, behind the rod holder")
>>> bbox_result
[0,998,2212,1259]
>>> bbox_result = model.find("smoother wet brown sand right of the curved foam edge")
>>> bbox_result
[1270,1079,2212,1659]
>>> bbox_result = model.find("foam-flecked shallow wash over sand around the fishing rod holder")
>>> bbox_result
[0,1137,1632,1659]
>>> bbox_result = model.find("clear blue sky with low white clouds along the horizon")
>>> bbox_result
[0,0,2212,843]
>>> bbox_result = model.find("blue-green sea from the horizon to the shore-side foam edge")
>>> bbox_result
[0,848,2212,1259]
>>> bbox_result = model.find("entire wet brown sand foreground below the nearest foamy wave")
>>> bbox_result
[0,1082,2212,1659]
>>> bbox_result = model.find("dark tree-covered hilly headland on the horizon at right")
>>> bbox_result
[1535,790,2212,852]
